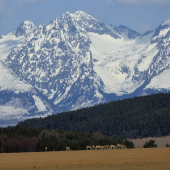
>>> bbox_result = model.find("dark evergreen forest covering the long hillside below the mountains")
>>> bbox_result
[18,93,170,139]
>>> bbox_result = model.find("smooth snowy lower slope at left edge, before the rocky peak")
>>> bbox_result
[0,58,53,126]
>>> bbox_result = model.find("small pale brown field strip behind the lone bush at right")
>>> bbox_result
[131,136,170,148]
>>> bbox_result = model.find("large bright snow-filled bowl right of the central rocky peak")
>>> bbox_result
[88,33,153,95]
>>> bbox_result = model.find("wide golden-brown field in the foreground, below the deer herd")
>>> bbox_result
[0,148,170,170]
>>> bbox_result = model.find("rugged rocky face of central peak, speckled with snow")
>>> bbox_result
[7,12,112,111]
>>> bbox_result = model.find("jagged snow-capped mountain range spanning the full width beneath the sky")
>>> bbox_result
[0,11,170,125]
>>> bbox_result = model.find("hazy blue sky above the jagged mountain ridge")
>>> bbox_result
[0,0,170,35]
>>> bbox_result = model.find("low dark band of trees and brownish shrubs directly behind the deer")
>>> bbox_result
[0,126,134,153]
